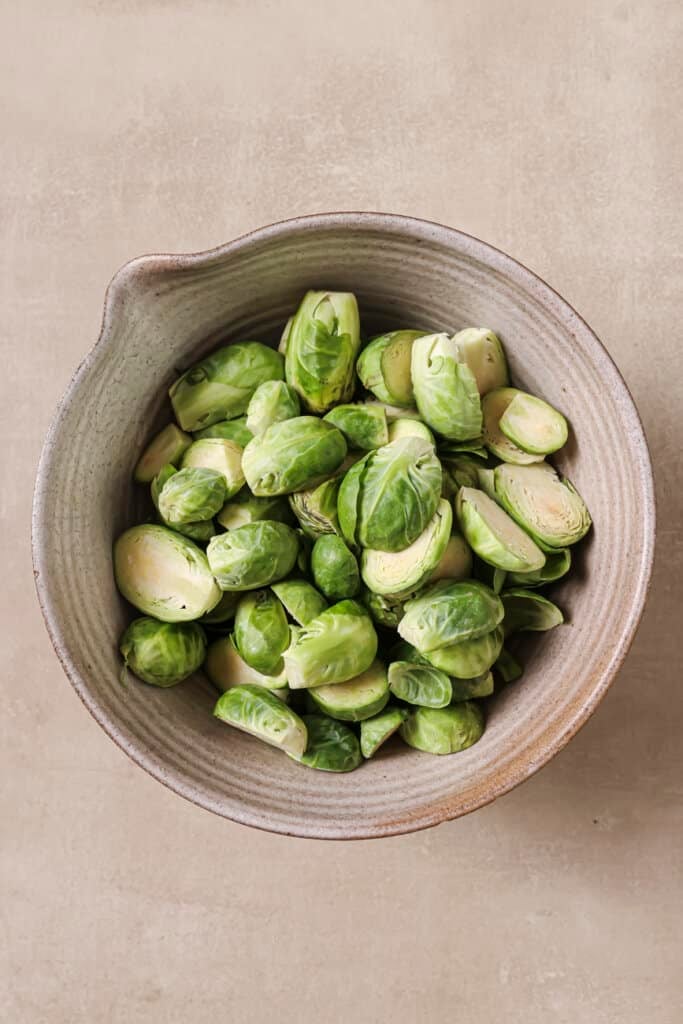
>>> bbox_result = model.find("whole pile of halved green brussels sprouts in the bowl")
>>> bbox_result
[114,292,591,771]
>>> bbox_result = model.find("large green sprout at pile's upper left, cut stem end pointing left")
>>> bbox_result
[169,341,285,430]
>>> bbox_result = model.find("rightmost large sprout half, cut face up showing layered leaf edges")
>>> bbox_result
[496,463,591,548]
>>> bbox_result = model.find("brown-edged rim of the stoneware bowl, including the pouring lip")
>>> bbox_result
[31,211,656,840]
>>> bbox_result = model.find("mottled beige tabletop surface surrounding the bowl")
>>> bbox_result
[0,0,683,1024]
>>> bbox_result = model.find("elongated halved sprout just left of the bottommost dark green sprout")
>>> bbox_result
[213,684,308,758]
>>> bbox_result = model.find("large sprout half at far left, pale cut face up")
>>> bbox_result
[114,523,220,623]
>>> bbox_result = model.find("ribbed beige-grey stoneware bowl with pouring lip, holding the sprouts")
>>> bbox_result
[33,213,654,839]
